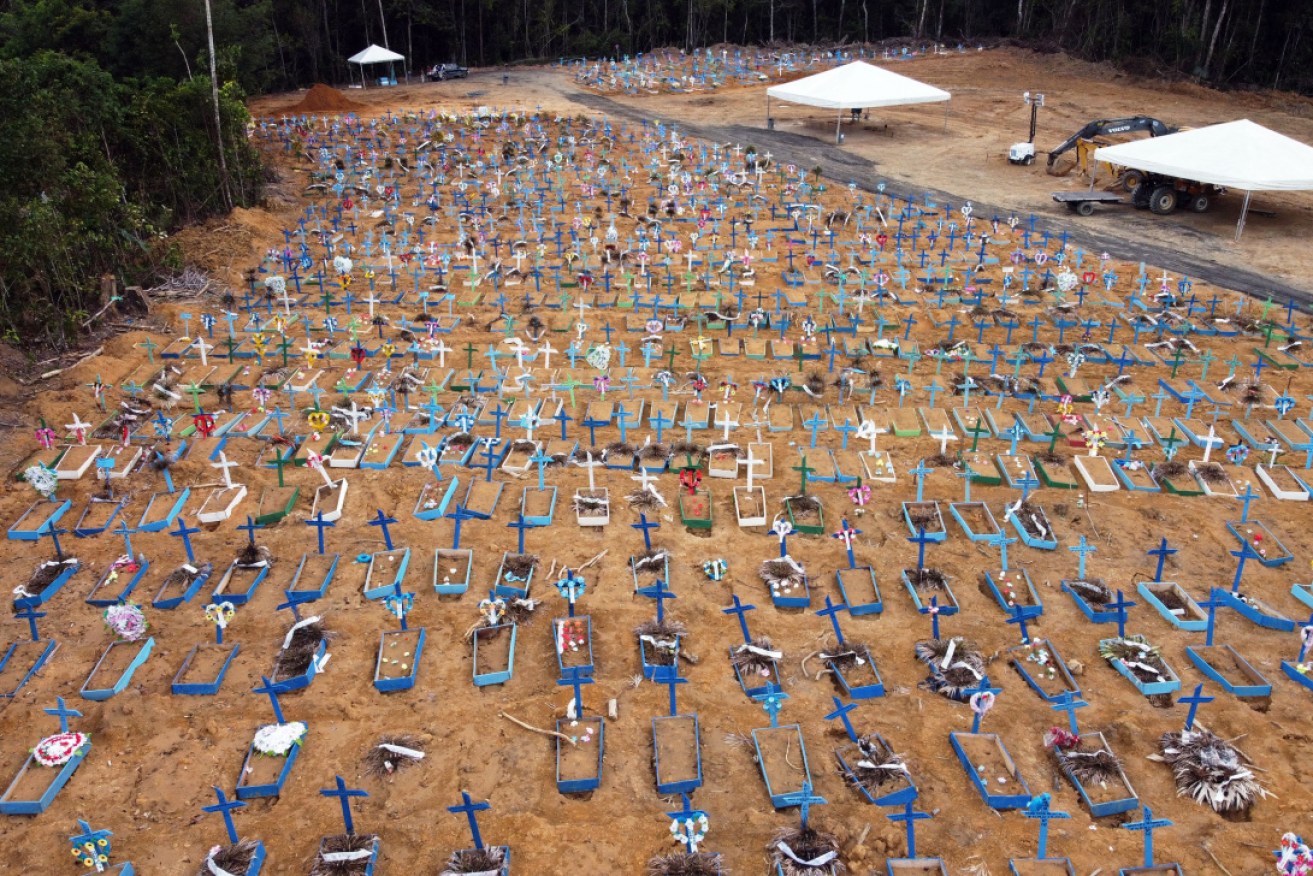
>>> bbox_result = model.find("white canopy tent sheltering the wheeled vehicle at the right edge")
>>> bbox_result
[1094,118,1313,240]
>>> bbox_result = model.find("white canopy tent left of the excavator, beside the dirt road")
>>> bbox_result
[765,60,952,141]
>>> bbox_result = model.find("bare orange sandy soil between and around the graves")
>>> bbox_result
[0,53,1313,875]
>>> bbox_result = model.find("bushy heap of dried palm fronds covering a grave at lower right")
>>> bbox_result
[1158,728,1268,814]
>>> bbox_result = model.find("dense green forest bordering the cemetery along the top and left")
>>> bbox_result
[0,0,1313,344]
